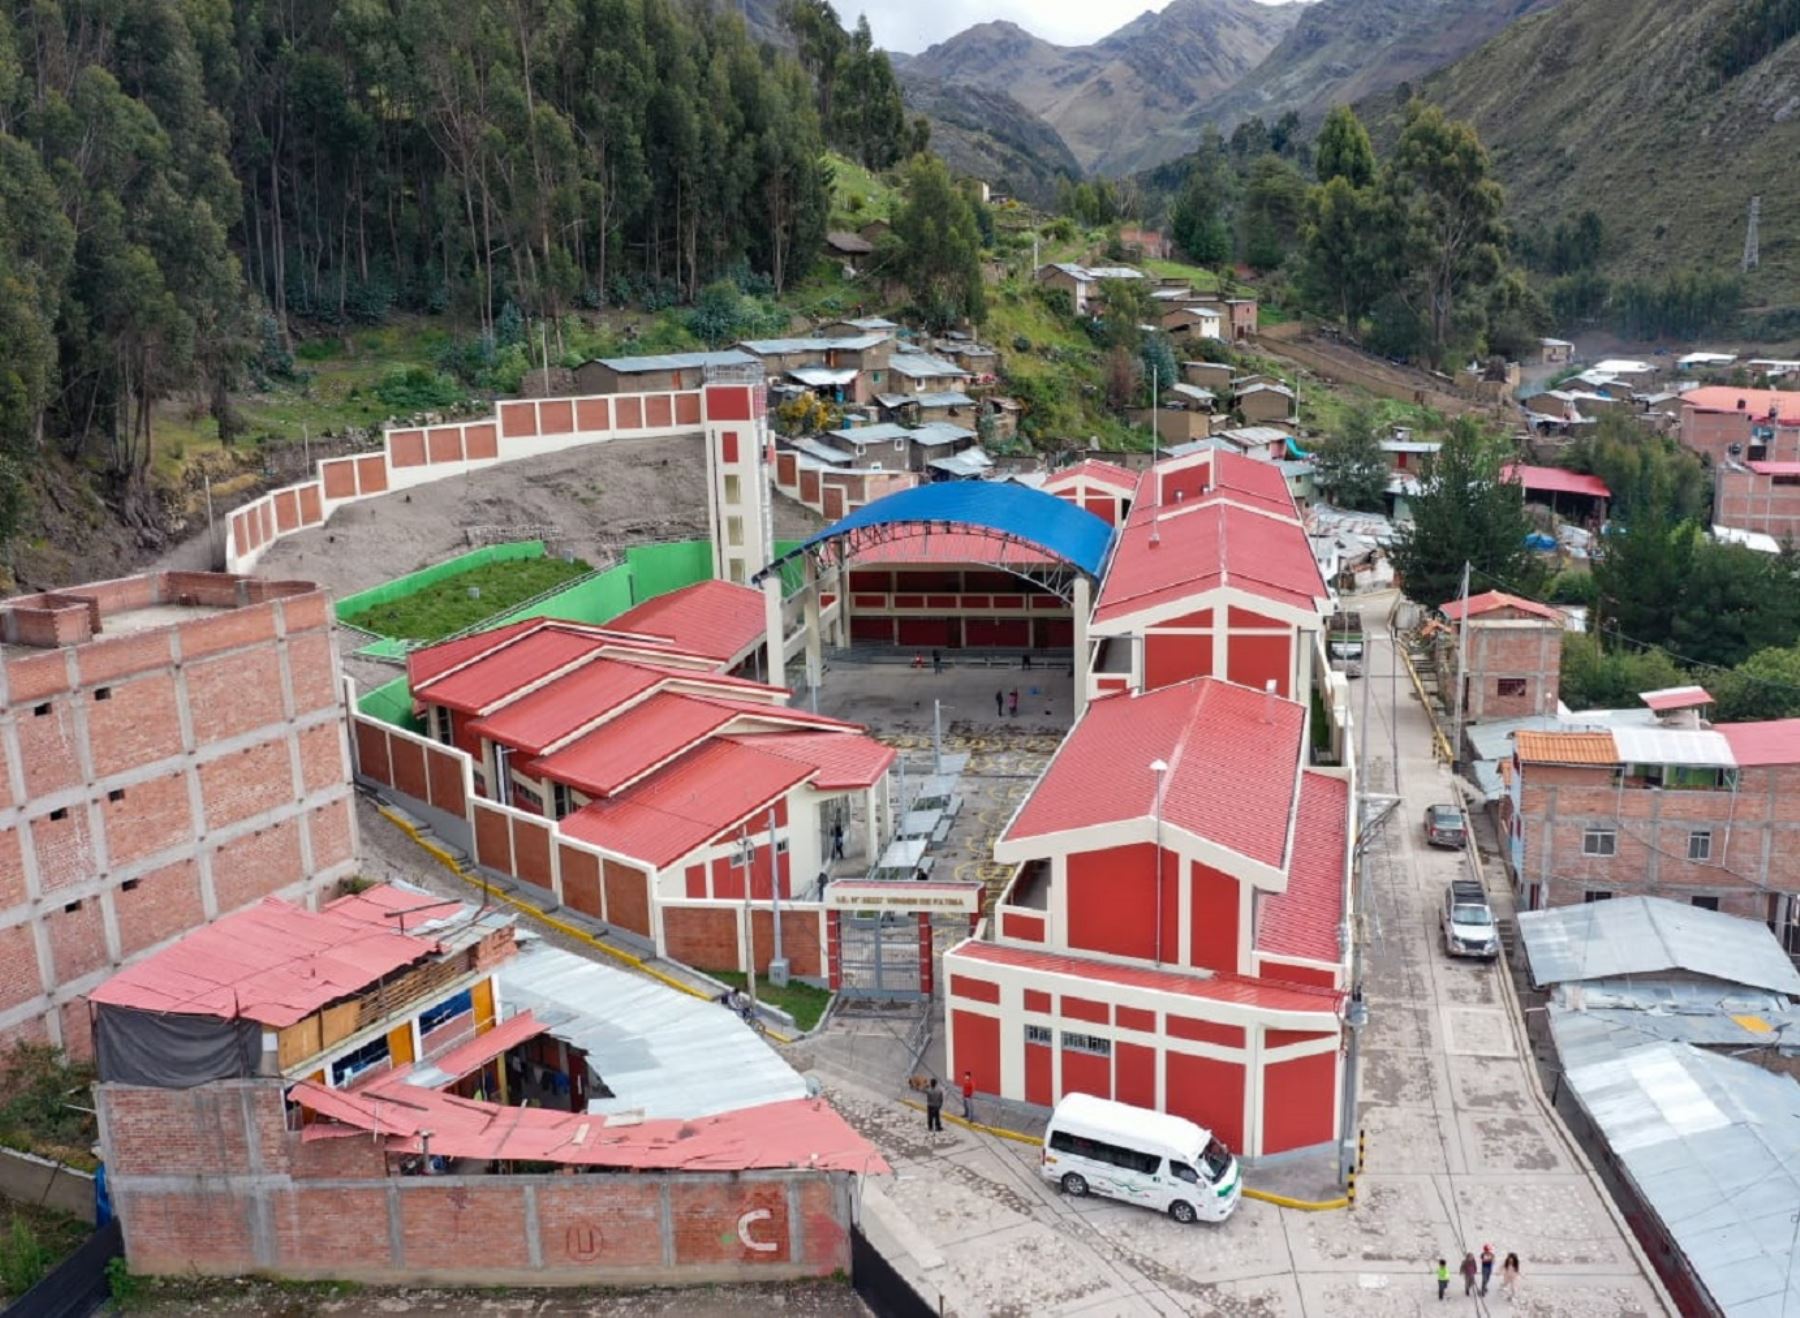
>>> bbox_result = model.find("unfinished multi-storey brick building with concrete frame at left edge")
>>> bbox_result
[0,573,356,1055]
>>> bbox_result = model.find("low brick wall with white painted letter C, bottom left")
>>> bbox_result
[97,1080,850,1286]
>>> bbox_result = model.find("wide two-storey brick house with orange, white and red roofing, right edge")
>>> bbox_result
[1501,688,1800,949]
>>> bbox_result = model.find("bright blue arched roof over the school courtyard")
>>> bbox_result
[783,481,1112,580]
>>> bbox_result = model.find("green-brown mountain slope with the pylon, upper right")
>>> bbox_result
[1364,0,1800,308]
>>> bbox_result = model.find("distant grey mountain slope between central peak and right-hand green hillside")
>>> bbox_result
[1123,0,1562,169]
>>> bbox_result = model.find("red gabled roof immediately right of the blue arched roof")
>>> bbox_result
[1094,500,1325,623]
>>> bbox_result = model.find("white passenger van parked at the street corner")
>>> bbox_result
[1039,1093,1244,1223]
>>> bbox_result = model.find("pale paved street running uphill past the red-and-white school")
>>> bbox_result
[830,600,1665,1318]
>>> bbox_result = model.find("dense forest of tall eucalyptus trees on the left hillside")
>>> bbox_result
[0,0,842,540]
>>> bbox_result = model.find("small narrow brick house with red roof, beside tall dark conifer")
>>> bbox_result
[1440,591,1562,724]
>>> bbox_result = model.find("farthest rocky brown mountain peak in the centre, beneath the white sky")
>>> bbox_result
[905,0,1307,175]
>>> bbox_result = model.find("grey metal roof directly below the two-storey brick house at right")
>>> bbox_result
[1519,897,1800,996]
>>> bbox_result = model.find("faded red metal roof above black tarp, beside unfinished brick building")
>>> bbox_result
[88,897,437,1030]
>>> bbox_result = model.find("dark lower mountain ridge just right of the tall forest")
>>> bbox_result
[896,65,1082,207]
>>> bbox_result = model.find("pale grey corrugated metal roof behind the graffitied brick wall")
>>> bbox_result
[499,938,806,1120]
